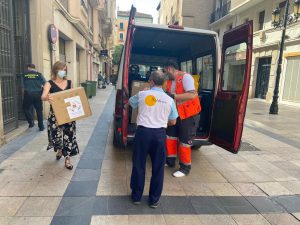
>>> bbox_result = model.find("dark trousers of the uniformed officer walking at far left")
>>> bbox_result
[23,92,44,128]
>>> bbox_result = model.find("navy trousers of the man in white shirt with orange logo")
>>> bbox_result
[130,127,166,203]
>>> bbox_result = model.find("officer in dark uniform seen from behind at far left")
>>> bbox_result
[21,63,46,131]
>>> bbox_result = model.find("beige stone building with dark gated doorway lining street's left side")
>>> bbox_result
[0,0,115,142]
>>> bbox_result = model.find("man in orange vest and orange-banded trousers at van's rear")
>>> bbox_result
[164,61,201,177]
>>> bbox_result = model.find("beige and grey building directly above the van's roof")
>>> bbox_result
[157,0,214,29]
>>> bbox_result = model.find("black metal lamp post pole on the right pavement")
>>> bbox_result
[270,0,290,115]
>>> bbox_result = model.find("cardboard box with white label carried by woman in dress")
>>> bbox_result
[52,87,92,125]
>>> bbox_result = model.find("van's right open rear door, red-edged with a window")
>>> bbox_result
[209,21,253,153]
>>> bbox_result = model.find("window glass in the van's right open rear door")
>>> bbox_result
[222,43,247,91]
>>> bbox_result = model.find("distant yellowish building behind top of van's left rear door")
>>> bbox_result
[115,11,153,45]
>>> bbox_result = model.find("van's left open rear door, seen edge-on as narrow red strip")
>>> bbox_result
[122,6,136,146]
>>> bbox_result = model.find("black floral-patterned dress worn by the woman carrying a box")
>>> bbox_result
[47,80,79,156]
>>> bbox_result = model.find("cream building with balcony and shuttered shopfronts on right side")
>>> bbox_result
[210,0,300,105]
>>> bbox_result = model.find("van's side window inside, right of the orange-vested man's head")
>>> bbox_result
[196,55,214,90]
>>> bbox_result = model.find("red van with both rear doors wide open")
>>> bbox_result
[113,7,253,153]
